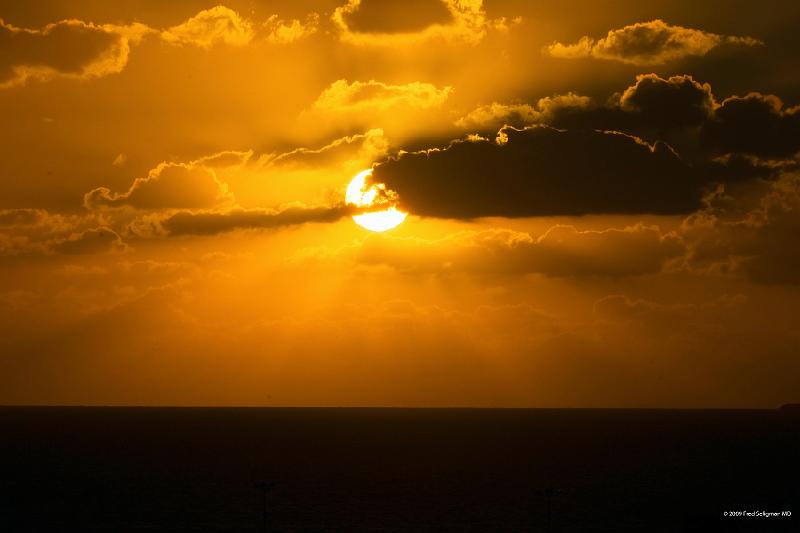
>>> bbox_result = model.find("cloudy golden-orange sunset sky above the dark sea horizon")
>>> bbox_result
[0,0,800,407]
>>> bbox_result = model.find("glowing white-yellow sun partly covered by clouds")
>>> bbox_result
[344,169,408,231]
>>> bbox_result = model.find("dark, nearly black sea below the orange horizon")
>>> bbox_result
[0,407,800,532]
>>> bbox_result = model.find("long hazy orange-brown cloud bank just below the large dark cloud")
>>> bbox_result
[357,225,684,278]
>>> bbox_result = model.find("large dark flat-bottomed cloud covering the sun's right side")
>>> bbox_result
[372,126,704,218]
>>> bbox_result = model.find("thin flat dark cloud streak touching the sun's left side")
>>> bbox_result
[160,205,353,235]
